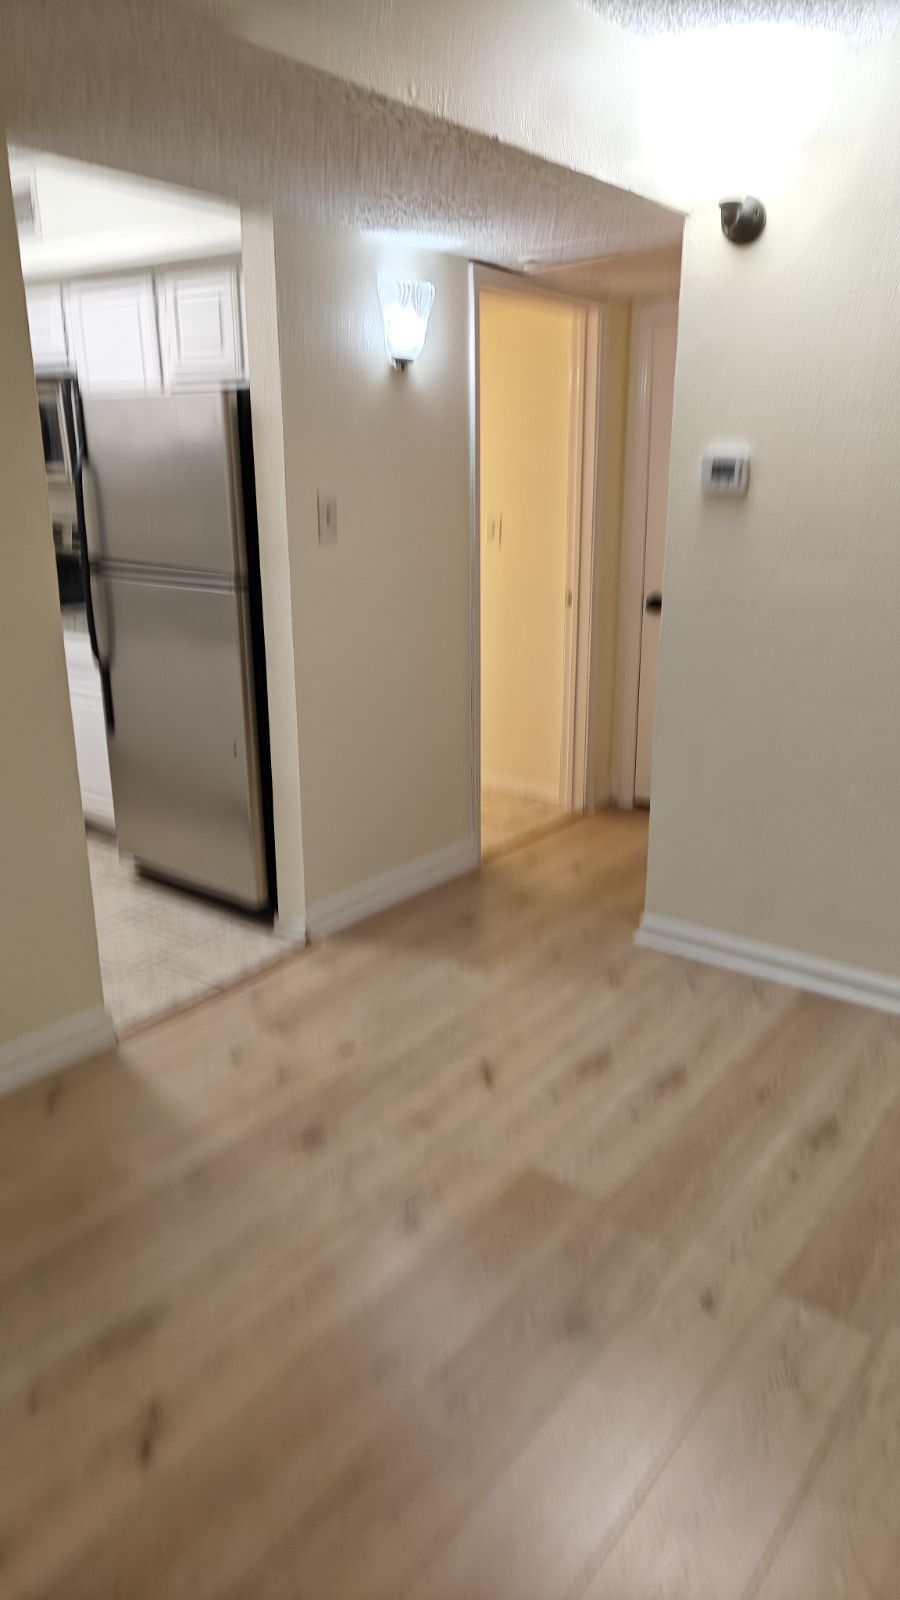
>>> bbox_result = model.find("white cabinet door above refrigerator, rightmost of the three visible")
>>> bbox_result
[157,266,245,389]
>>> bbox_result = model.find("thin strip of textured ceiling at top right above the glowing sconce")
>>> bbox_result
[581,0,900,38]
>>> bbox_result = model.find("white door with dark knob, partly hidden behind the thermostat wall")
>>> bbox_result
[634,306,676,805]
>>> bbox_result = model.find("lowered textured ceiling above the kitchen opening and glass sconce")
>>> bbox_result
[0,0,682,266]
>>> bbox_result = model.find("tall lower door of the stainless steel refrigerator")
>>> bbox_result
[102,573,267,907]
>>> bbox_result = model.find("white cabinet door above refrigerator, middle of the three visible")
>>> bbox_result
[66,274,162,394]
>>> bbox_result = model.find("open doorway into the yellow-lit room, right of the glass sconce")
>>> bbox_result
[476,288,599,858]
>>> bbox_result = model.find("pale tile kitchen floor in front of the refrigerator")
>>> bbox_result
[88,830,287,1030]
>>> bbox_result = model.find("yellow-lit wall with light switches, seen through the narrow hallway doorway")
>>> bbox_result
[479,290,570,800]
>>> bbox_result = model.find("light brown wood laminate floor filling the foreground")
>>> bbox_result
[0,816,900,1600]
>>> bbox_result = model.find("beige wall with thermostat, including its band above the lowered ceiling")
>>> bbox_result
[254,0,900,974]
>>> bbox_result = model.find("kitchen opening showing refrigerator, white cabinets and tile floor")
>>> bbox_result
[10,149,285,1030]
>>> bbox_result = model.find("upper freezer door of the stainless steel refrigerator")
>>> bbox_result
[82,390,243,574]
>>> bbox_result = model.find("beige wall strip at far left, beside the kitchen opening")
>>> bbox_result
[0,162,102,1048]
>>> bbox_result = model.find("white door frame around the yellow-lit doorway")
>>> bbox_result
[469,262,604,859]
